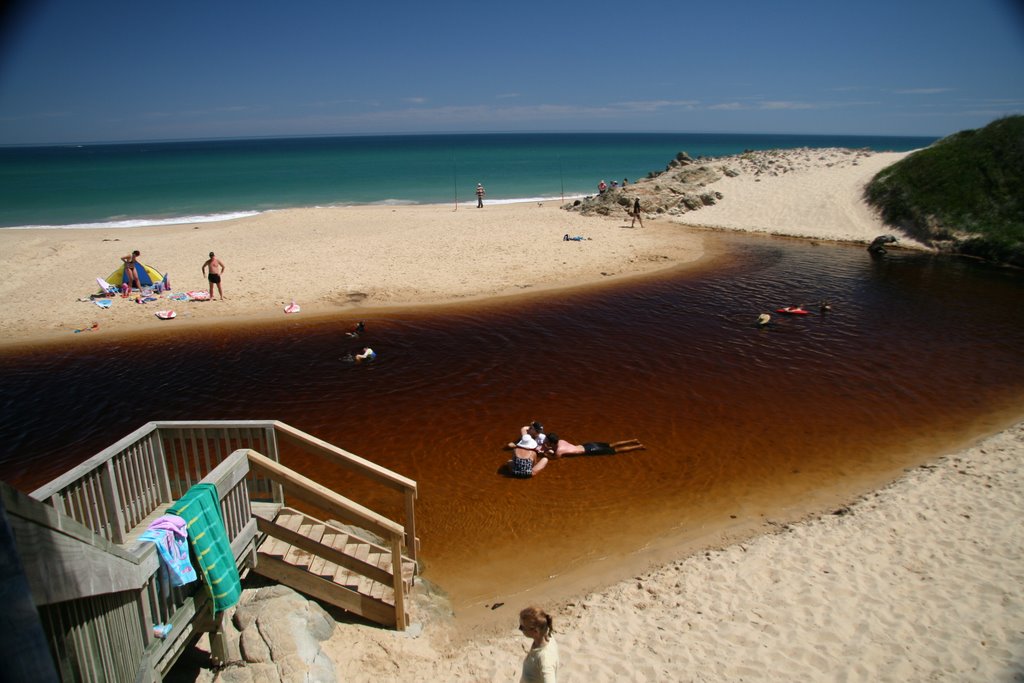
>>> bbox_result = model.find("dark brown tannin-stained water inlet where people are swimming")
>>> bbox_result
[0,237,1024,613]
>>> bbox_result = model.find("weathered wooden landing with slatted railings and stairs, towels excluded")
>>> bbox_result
[7,420,419,683]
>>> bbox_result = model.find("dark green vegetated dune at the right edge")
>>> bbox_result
[864,116,1024,266]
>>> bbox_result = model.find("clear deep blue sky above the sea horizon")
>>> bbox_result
[0,0,1024,144]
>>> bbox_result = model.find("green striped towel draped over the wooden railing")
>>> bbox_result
[173,483,242,613]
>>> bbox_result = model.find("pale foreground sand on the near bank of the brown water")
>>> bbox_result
[325,423,1024,682]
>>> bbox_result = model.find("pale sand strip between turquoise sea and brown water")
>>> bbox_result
[0,151,905,348]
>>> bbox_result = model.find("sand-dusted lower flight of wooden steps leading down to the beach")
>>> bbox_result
[253,508,416,628]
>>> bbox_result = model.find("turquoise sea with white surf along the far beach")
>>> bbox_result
[0,133,935,227]
